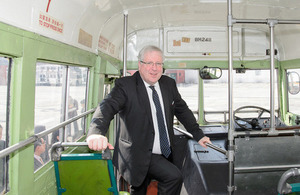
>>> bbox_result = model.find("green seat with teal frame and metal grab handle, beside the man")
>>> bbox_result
[51,143,129,195]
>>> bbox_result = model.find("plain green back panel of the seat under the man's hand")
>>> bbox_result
[58,160,113,195]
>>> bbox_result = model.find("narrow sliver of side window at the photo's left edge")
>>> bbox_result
[0,57,11,194]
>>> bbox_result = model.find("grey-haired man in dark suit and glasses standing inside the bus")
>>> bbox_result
[87,46,211,195]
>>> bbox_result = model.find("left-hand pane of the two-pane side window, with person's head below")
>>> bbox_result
[34,62,66,170]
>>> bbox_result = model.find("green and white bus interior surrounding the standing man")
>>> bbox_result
[0,0,300,195]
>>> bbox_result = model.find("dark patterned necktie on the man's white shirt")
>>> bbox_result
[150,86,171,158]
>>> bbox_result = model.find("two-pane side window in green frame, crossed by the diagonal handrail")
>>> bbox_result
[34,62,88,170]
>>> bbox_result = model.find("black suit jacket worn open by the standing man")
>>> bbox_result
[88,72,204,186]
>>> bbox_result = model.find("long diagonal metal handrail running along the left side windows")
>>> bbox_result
[0,108,96,159]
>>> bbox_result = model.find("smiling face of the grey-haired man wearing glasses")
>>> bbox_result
[139,51,163,85]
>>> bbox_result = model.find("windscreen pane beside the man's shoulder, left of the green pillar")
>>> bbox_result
[165,69,199,119]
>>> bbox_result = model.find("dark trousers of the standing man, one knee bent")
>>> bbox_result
[131,154,183,195]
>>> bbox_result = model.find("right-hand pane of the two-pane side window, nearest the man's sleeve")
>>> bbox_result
[66,67,88,141]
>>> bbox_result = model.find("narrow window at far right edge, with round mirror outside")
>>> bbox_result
[287,69,300,114]
